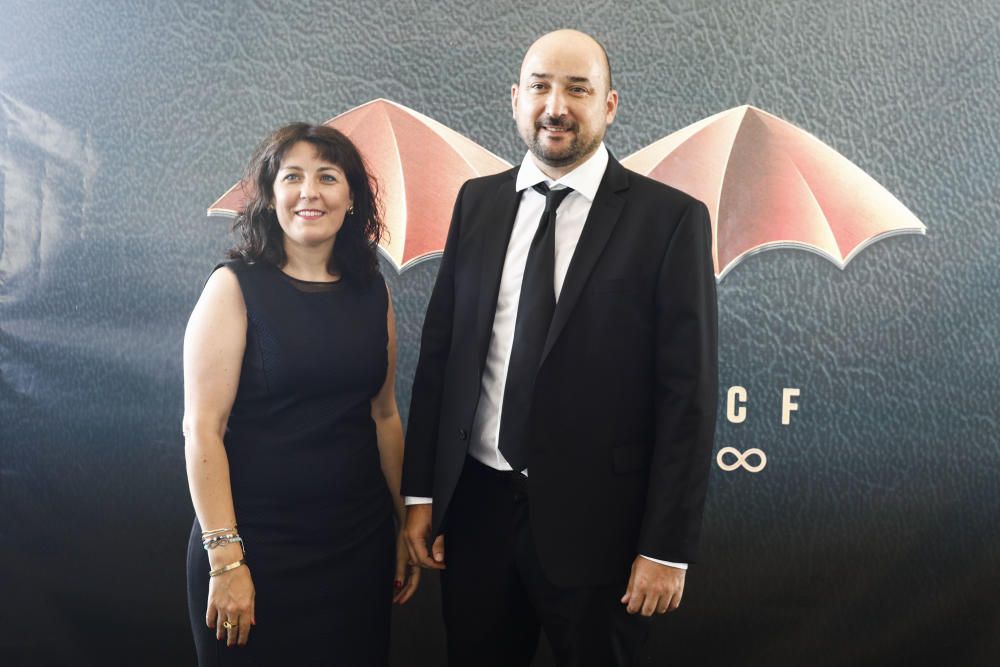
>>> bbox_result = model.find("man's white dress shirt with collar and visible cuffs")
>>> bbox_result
[406,143,687,569]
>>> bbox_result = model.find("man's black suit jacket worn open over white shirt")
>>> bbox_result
[403,158,718,586]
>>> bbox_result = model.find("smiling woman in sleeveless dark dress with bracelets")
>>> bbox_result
[184,124,419,667]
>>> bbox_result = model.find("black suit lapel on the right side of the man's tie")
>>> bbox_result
[539,157,628,366]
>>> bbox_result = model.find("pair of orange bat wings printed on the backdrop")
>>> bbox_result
[208,99,927,281]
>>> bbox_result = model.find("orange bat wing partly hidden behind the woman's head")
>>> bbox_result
[208,99,510,272]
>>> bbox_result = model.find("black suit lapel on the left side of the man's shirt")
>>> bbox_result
[476,168,521,373]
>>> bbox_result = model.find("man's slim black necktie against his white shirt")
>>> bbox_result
[500,183,573,470]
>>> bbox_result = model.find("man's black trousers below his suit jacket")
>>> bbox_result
[441,458,649,667]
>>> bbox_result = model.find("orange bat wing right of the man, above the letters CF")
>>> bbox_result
[622,106,927,280]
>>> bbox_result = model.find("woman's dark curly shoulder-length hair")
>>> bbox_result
[229,123,385,283]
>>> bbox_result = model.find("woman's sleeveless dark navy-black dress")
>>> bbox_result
[187,261,395,667]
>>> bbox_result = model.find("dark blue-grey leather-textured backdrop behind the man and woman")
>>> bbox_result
[0,0,1000,667]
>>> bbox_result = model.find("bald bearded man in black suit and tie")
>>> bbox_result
[403,30,717,667]
